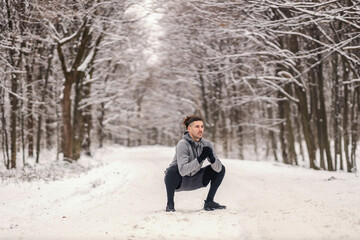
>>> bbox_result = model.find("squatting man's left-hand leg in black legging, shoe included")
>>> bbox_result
[164,166,182,211]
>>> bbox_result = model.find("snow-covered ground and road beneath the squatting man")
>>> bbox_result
[0,147,360,240]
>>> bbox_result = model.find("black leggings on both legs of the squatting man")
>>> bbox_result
[165,165,225,204]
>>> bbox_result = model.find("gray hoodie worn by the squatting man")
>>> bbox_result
[169,131,222,177]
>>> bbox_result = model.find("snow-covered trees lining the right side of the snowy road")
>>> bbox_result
[162,0,360,172]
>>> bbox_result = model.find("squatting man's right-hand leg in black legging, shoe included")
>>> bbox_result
[203,165,225,210]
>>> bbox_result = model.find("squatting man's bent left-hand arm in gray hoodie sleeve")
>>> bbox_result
[176,141,201,177]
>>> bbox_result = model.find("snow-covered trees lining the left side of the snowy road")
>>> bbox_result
[0,0,165,169]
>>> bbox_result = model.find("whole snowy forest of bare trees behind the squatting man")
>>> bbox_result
[0,0,360,172]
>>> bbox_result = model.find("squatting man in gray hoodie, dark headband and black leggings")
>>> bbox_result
[165,116,226,212]
